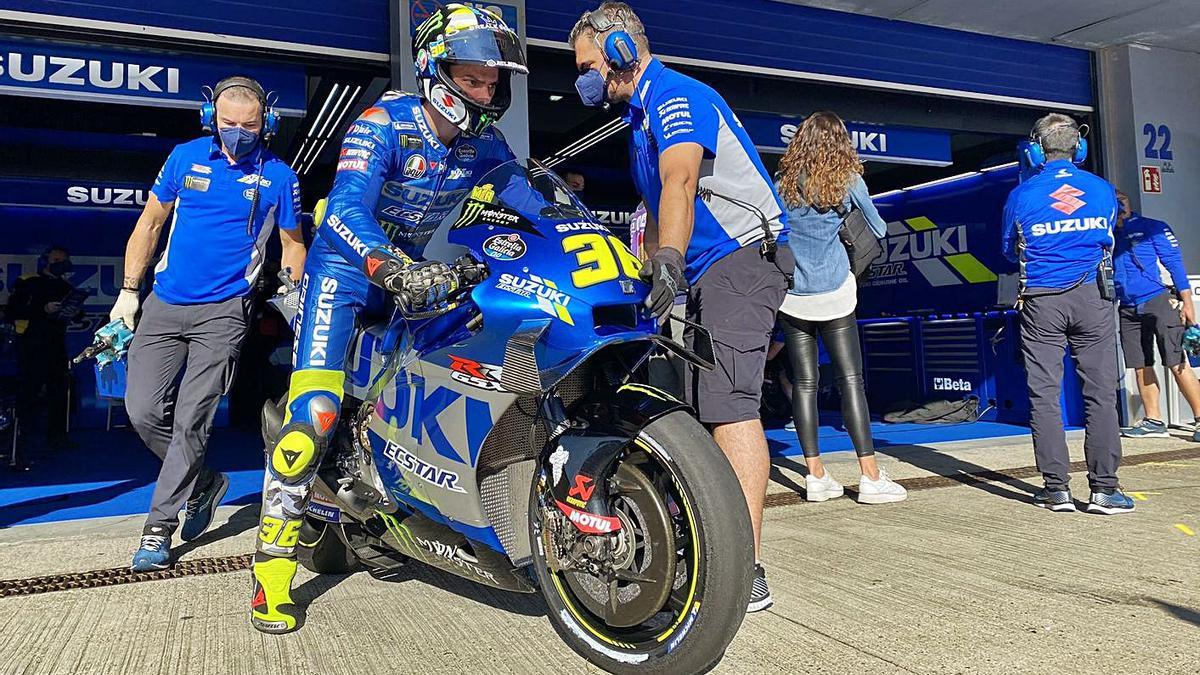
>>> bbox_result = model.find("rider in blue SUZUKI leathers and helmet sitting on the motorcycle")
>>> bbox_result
[251,4,528,633]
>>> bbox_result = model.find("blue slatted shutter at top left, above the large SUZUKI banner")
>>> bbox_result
[0,0,389,55]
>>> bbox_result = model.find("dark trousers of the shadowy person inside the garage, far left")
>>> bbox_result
[17,335,71,441]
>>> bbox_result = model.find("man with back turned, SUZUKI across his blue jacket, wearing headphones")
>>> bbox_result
[1001,113,1133,514]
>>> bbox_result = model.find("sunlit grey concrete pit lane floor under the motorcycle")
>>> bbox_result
[0,434,1200,675]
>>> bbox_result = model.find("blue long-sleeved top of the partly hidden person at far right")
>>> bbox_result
[1112,214,1192,307]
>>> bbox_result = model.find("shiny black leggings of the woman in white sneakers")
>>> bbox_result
[779,312,875,458]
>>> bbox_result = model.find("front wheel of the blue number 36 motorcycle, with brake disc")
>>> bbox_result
[529,411,754,674]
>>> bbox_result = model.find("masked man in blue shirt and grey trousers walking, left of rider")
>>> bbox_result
[110,77,305,572]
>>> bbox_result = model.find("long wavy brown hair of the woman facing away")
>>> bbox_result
[779,110,863,208]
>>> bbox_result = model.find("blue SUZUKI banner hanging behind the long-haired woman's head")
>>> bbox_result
[738,113,952,167]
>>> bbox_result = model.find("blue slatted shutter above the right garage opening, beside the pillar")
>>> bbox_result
[526,0,1092,107]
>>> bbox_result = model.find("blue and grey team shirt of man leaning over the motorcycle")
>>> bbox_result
[624,54,787,283]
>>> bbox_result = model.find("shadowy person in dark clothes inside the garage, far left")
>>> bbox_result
[5,246,79,449]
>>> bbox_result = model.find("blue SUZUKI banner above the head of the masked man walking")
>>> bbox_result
[0,38,307,117]
